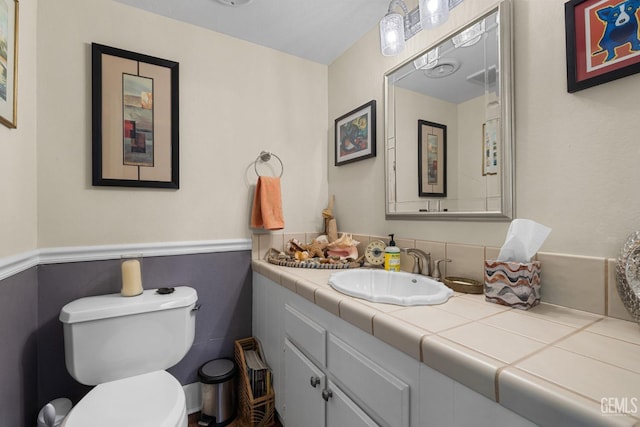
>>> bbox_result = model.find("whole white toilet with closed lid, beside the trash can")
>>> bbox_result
[60,286,198,427]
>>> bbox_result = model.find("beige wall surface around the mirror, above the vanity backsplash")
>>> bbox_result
[329,0,640,257]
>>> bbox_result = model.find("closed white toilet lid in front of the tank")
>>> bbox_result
[62,371,186,427]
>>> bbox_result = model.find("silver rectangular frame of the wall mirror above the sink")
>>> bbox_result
[384,0,515,221]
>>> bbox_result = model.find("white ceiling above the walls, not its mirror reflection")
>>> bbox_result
[116,0,389,65]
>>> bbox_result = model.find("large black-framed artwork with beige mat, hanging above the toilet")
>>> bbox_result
[92,42,179,189]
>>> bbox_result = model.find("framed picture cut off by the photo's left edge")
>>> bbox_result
[0,0,18,129]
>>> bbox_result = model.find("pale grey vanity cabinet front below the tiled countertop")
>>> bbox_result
[253,272,533,427]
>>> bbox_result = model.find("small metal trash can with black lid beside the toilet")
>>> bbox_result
[198,359,238,427]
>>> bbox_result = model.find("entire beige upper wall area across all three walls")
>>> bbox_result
[0,0,640,257]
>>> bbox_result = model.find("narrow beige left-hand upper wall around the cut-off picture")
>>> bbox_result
[0,1,38,258]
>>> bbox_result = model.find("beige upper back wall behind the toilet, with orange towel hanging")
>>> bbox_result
[33,0,328,248]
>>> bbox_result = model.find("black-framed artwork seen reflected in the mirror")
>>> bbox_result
[418,120,447,197]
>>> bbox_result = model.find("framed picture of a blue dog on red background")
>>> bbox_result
[564,0,640,92]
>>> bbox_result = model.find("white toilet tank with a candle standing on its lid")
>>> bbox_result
[60,286,198,385]
